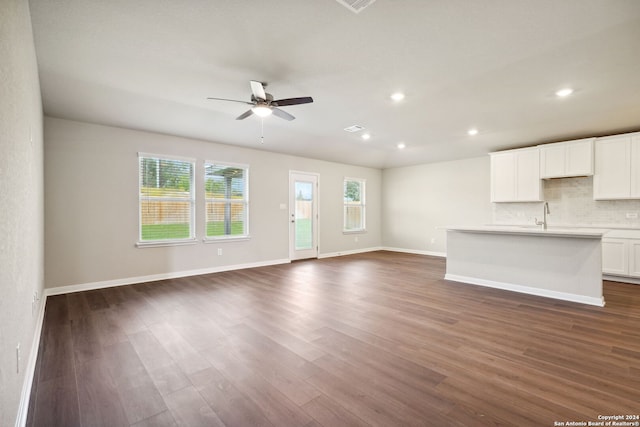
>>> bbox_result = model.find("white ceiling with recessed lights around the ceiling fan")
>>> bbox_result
[30,0,640,168]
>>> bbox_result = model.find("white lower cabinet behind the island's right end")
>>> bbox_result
[602,237,640,277]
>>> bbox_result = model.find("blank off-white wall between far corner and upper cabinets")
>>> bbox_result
[382,156,492,255]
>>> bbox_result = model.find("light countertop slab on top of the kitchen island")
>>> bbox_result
[444,225,608,239]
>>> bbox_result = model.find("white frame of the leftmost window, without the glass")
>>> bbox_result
[136,152,197,248]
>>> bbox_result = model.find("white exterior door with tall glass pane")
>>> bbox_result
[289,172,318,261]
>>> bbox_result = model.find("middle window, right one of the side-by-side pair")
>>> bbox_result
[204,162,249,239]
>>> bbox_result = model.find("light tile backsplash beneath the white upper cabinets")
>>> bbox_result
[493,177,640,228]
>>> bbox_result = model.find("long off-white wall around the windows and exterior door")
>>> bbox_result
[44,117,382,288]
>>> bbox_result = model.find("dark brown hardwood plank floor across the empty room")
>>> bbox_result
[28,252,640,427]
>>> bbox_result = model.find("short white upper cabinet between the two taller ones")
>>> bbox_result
[538,138,595,179]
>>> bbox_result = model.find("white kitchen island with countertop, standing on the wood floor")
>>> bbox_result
[445,226,605,306]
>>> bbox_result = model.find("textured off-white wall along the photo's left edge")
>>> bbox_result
[0,0,44,426]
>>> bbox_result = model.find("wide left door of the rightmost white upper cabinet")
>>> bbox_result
[593,136,631,200]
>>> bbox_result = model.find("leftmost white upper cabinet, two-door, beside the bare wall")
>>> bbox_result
[490,147,542,202]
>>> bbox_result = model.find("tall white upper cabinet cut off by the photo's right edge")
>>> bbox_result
[593,134,640,200]
